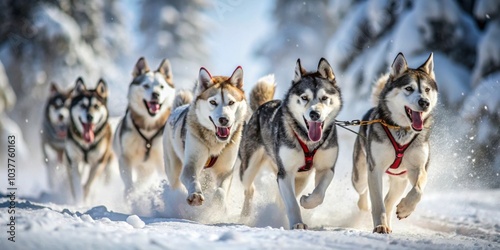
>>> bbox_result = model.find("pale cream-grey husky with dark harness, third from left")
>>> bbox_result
[113,57,175,195]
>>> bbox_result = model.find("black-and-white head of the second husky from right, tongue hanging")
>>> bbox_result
[286,58,342,142]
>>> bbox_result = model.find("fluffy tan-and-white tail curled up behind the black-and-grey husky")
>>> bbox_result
[250,74,276,111]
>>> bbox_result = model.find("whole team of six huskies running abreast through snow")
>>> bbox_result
[42,53,438,234]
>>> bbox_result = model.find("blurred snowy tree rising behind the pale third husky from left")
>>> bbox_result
[139,0,210,88]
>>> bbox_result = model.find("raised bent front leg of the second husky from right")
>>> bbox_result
[300,169,333,209]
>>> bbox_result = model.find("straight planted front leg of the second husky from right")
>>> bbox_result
[278,173,307,229]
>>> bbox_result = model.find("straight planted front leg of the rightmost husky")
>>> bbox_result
[368,166,391,234]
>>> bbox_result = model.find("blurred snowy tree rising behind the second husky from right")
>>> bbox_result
[257,0,336,97]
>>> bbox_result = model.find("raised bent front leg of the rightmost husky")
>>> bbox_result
[396,167,427,220]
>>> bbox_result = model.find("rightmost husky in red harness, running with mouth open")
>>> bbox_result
[352,53,438,234]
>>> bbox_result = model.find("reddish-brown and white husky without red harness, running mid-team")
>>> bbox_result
[163,67,247,206]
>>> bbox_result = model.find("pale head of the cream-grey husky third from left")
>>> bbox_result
[128,57,175,117]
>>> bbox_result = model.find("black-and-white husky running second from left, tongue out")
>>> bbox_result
[65,78,113,203]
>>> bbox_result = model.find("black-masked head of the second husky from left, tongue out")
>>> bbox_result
[70,78,108,144]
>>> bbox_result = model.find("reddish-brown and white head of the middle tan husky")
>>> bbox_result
[195,66,247,142]
